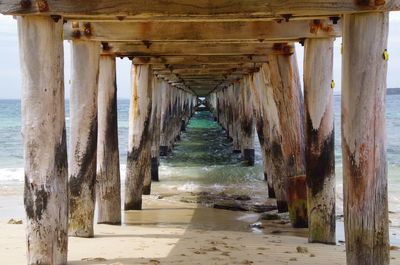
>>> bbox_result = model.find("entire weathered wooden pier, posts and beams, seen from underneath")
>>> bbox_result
[0,0,394,265]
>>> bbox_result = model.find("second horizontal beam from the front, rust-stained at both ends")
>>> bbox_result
[64,20,341,42]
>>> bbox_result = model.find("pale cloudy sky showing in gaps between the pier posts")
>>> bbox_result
[0,12,400,99]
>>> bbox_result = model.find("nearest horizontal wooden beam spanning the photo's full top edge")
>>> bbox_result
[0,0,400,20]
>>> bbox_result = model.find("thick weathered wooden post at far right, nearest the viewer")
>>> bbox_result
[342,13,389,265]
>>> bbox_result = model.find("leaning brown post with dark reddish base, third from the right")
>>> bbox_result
[264,54,308,227]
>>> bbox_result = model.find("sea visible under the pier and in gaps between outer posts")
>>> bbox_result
[0,95,400,244]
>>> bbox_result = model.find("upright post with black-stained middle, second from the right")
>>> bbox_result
[304,39,336,244]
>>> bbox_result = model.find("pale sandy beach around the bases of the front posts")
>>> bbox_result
[0,196,400,265]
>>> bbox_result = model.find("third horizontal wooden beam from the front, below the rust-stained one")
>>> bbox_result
[102,41,294,57]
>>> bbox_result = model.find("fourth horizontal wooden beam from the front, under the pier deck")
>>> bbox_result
[132,55,268,65]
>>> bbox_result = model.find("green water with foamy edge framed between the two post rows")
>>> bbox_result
[159,111,268,199]
